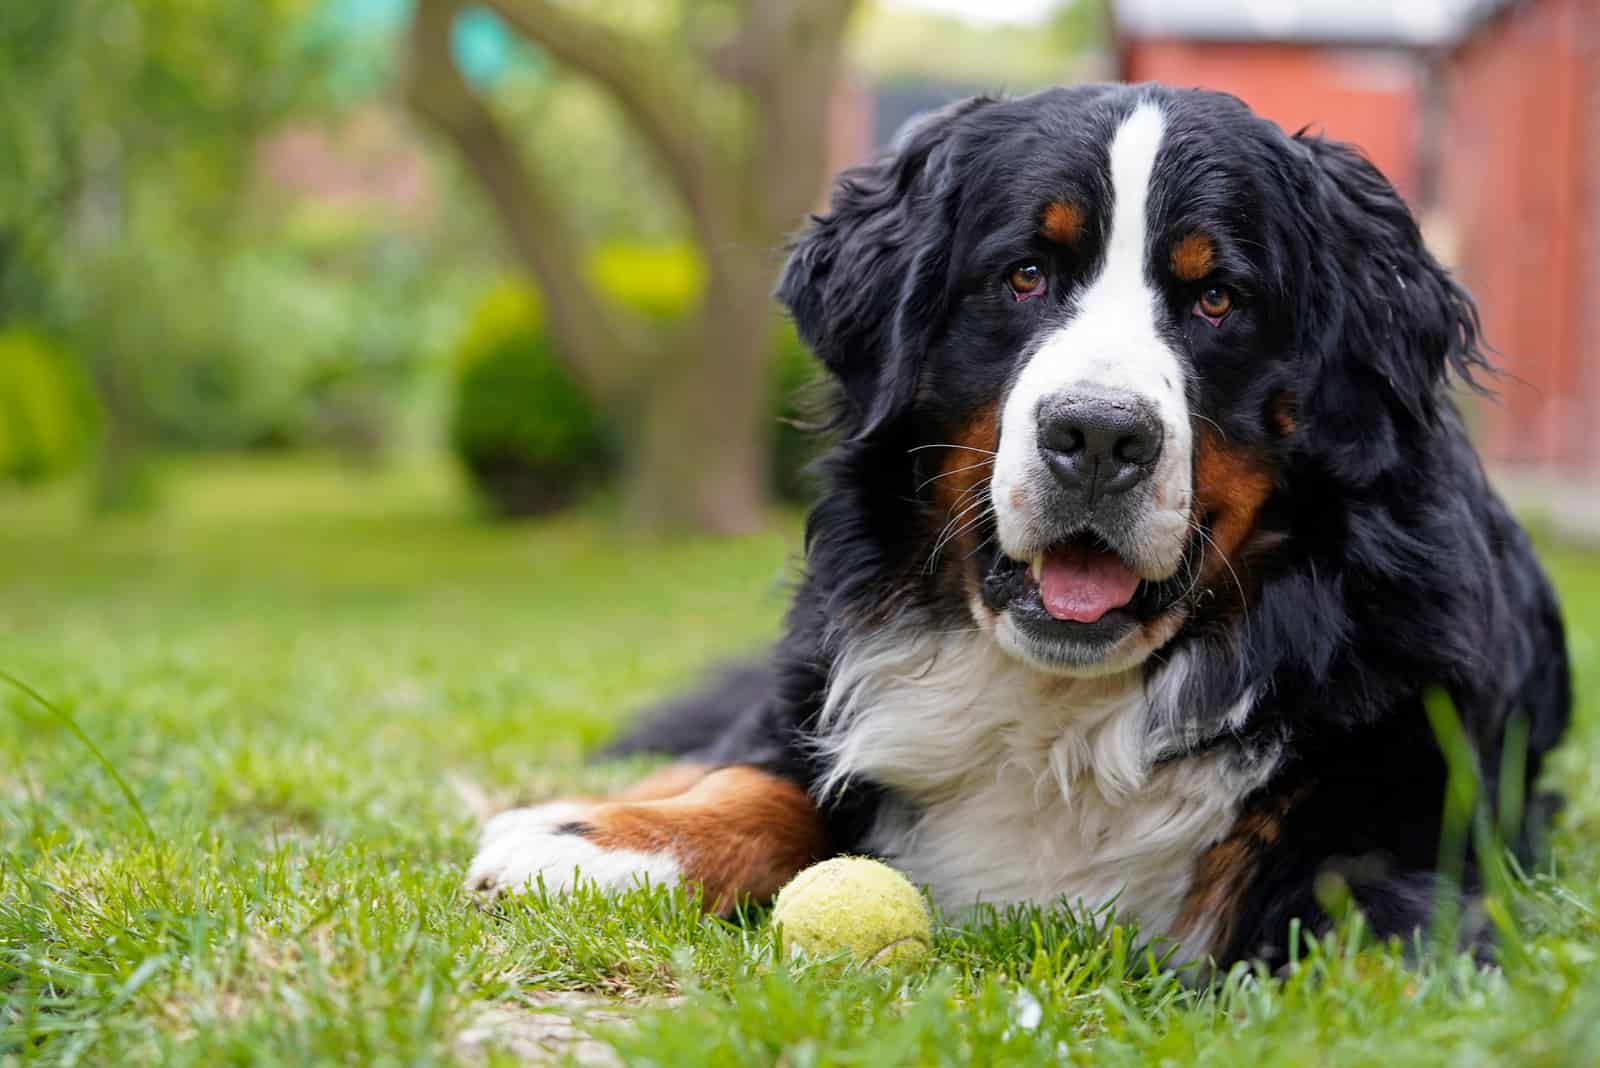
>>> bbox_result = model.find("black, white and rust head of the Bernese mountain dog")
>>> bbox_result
[778,86,1477,675]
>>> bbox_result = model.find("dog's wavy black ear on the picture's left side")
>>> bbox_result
[778,99,987,438]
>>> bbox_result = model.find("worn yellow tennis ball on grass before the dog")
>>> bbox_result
[773,857,933,964]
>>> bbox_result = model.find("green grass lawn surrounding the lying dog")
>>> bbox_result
[0,460,1600,1066]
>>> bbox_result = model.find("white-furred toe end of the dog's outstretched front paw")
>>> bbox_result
[467,801,682,894]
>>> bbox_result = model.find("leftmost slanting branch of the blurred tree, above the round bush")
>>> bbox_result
[406,0,646,395]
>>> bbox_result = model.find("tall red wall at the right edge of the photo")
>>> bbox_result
[1443,0,1600,475]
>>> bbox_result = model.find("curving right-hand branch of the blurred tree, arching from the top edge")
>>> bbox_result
[485,0,741,246]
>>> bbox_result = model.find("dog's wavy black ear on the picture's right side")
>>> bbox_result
[1294,133,1490,483]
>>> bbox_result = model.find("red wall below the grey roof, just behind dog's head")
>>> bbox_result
[1122,39,1426,198]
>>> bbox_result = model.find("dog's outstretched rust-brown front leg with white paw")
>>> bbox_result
[467,766,827,915]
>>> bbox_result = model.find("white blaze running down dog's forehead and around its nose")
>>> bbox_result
[994,101,1192,577]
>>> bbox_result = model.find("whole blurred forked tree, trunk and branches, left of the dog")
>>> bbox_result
[408,0,854,532]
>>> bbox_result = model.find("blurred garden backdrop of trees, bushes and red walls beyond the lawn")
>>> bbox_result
[0,0,1600,534]
